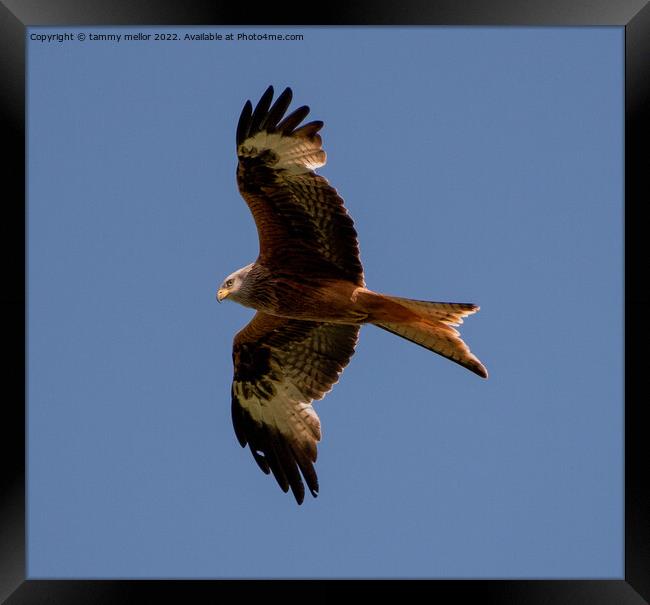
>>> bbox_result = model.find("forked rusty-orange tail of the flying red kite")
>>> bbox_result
[372,295,488,378]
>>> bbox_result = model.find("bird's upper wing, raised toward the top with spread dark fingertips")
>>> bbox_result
[237,86,364,286]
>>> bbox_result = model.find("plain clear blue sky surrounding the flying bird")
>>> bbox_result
[28,27,624,578]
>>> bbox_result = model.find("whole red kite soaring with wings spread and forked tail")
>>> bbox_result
[217,86,487,504]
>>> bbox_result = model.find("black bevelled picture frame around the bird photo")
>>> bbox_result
[0,0,650,605]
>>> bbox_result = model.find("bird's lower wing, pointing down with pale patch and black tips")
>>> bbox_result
[232,312,359,504]
